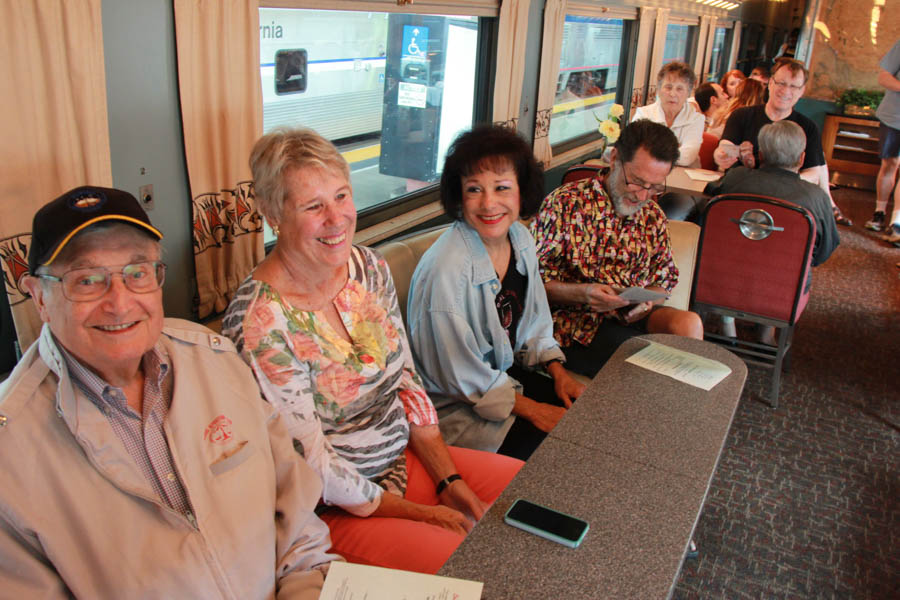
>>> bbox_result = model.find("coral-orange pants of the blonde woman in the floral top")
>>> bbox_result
[321,446,525,574]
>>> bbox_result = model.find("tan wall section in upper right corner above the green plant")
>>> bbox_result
[806,0,900,100]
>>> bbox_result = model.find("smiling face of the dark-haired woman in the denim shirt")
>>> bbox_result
[462,162,521,245]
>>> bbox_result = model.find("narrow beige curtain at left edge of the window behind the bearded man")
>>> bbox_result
[534,0,568,167]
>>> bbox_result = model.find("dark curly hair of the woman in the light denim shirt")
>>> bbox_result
[441,125,544,221]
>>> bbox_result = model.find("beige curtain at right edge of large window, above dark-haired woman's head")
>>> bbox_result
[494,0,530,129]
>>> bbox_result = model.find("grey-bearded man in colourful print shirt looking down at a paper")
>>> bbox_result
[531,119,703,377]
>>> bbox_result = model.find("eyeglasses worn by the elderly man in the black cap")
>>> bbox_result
[37,260,166,302]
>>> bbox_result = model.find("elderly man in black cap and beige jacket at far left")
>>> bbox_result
[0,187,336,599]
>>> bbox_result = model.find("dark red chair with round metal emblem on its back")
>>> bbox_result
[691,194,816,408]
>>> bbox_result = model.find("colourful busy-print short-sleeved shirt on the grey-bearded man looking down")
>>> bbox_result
[531,178,678,346]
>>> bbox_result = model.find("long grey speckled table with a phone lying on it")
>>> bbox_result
[439,335,747,600]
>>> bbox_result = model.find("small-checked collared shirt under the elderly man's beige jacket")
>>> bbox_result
[54,339,193,520]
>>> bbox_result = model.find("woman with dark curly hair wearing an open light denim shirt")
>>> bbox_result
[407,127,584,460]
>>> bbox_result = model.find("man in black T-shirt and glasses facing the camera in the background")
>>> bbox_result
[713,58,853,226]
